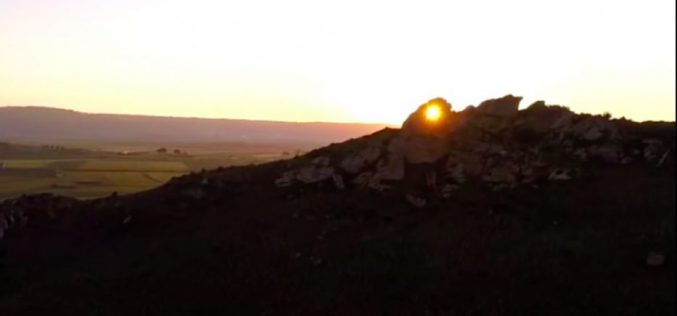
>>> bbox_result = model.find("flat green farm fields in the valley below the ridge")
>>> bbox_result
[0,144,302,200]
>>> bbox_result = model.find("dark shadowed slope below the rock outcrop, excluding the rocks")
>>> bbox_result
[0,130,676,315]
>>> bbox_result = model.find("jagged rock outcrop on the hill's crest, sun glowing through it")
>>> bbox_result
[275,95,674,201]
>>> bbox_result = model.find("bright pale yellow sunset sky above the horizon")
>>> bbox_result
[0,0,676,125]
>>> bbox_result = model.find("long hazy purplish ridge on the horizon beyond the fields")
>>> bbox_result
[0,106,385,143]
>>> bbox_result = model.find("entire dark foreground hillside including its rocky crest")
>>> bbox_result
[0,96,675,315]
